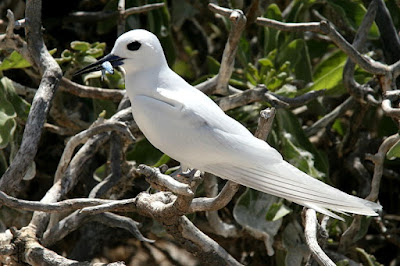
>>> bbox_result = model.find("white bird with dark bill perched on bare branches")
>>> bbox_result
[76,29,382,219]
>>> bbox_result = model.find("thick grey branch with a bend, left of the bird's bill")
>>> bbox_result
[0,0,62,195]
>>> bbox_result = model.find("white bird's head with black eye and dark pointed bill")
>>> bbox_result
[75,29,167,75]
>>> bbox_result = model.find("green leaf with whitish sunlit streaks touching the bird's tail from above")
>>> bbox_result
[275,109,329,181]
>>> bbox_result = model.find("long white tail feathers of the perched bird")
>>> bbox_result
[205,160,382,220]
